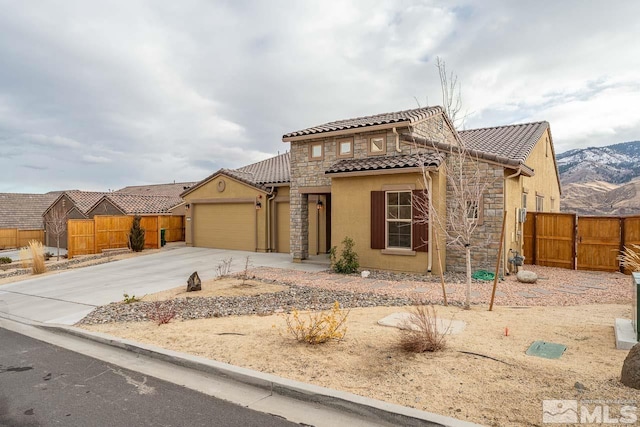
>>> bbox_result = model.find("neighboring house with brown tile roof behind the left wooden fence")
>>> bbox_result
[42,190,184,249]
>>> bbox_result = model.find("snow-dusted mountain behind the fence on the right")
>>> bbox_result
[556,141,640,215]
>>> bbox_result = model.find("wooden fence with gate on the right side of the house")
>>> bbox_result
[523,212,640,271]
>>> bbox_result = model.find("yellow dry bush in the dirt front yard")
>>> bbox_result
[285,301,349,344]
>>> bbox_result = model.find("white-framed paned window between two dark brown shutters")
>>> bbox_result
[387,191,412,249]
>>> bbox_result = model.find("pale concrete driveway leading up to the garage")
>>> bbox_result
[0,247,327,325]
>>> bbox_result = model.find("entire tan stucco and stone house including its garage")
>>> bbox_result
[181,107,560,272]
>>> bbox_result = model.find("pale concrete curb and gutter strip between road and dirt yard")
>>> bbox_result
[0,315,477,427]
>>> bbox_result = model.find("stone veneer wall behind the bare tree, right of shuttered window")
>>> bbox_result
[446,161,504,272]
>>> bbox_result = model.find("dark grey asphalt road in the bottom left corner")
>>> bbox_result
[0,328,296,427]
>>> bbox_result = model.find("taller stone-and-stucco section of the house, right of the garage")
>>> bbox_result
[283,107,560,272]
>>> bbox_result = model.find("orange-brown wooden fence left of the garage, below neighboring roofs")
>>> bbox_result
[67,215,184,258]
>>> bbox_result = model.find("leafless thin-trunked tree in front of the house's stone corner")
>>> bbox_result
[413,58,495,308]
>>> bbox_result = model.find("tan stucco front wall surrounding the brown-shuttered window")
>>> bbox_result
[331,174,441,273]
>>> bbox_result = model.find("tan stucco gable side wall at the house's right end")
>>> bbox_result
[522,129,560,212]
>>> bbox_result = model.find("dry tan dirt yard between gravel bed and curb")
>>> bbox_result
[79,270,640,426]
